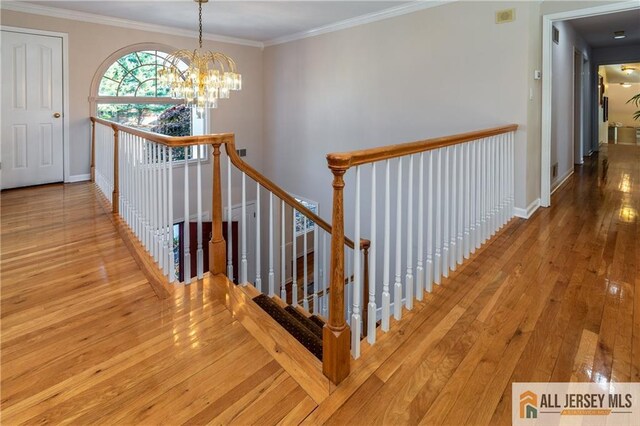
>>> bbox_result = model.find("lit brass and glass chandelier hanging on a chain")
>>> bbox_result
[158,0,242,110]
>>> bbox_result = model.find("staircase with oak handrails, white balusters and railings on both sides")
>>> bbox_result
[91,117,518,390]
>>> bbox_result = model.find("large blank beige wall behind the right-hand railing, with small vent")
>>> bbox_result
[264,2,539,217]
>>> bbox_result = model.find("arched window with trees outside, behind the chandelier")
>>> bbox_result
[92,44,205,160]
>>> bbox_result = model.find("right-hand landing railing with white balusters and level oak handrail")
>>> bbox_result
[327,125,517,358]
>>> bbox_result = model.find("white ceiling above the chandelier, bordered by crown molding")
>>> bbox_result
[20,0,416,42]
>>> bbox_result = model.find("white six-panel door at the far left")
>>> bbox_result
[0,30,64,189]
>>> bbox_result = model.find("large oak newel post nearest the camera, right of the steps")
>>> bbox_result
[322,158,351,384]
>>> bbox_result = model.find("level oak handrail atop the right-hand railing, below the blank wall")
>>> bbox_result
[327,124,518,170]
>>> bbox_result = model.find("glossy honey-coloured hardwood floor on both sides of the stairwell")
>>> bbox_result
[1,145,640,425]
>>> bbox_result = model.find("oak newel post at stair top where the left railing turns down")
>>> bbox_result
[209,138,227,274]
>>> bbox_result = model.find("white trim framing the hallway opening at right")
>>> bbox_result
[540,0,640,207]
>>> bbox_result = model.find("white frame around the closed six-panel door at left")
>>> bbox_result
[2,25,70,183]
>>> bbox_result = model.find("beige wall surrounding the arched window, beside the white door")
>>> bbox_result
[2,10,263,176]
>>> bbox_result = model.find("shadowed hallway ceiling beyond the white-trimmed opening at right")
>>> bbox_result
[569,9,640,48]
